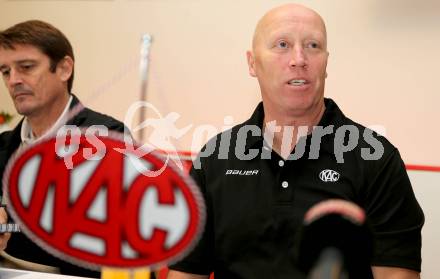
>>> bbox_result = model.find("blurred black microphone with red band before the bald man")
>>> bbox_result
[295,199,373,279]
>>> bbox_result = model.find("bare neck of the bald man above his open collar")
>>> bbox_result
[263,102,325,159]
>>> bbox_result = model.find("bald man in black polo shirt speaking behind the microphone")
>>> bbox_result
[168,4,424,279]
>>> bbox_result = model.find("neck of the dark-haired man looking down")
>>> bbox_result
[26,94,70,138]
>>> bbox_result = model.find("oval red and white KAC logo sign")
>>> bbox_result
[4,135,205,269]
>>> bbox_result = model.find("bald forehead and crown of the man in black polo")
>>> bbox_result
[253,6,327,47]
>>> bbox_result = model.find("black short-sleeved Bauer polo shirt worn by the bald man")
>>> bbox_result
[171,99,424,279]
